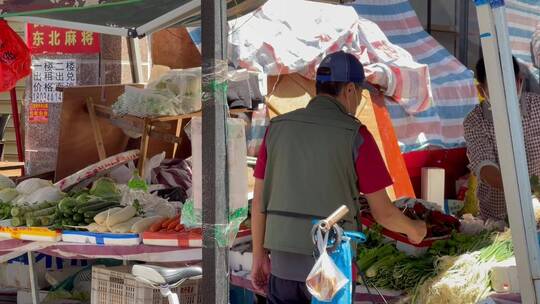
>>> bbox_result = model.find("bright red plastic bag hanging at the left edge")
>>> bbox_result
[0,20,30,92]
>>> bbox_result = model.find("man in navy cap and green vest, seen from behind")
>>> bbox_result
[251,52,426,304]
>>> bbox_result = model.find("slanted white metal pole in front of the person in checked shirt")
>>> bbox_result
[475,0,540,303]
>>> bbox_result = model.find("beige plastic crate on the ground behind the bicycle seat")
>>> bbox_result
[91,266,202,304]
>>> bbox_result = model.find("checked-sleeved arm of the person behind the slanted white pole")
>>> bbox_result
[463,108,503,190]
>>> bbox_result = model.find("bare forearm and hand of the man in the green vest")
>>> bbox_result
[365,189,427,244]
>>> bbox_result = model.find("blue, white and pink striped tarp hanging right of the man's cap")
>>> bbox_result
[353,0,478,152]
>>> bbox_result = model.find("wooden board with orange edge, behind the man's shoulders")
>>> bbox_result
[266,74,415,200]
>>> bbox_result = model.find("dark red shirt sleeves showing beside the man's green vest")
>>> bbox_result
[254,127,393,194]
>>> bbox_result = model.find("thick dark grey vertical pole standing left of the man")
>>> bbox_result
[201,0,229,304]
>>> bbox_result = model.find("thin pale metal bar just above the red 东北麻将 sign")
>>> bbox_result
[5,16,129,37]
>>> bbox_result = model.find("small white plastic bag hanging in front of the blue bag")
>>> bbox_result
[306,229,349,302]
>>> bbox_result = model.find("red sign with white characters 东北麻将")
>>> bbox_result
[26,24,100,55]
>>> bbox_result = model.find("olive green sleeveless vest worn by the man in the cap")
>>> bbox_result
[262,96,361,255]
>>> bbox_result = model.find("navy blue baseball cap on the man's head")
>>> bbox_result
[316,51,375,91]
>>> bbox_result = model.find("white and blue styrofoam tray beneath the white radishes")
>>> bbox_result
[62,230,141,245]
